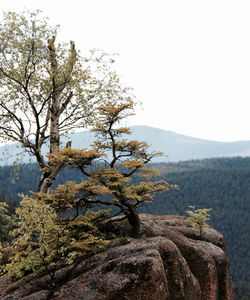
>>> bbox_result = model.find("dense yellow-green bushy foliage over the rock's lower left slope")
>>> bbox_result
[5,196,106,278]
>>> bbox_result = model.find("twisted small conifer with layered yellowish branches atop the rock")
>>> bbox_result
[46,101,177,237]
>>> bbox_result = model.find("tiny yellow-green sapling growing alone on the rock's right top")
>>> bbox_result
[186,205,212,235]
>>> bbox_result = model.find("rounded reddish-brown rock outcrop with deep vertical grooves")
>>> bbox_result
[0,215,233,300]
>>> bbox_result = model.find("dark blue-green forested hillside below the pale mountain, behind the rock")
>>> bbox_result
[0,157,250,299]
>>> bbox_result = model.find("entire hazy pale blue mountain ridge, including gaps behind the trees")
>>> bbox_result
[0,126,250,164]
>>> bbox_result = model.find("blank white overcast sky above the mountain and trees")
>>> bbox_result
[1,0,250,141]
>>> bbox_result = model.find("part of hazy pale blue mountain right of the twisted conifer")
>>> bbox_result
[131,126,250,162]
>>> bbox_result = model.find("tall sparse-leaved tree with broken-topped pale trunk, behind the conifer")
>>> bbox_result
[0,11,133,193]
